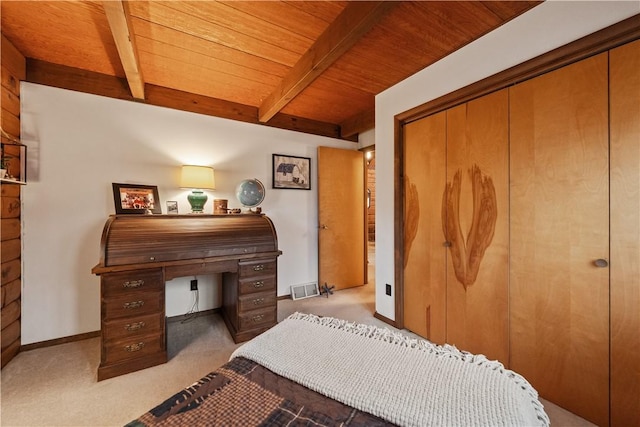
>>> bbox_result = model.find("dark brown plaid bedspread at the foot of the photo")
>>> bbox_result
[126,357,393,427]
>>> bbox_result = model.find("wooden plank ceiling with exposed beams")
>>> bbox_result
[0,0,539,140]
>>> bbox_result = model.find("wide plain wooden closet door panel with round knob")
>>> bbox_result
[510,53,609,426]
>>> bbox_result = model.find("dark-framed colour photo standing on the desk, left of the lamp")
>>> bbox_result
[112,182,162,215]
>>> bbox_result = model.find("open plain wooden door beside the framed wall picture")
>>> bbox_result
[318,147,367,290]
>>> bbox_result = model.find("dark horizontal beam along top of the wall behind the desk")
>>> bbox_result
[26,58,344,141]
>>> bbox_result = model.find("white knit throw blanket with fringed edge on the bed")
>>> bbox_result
[231,313,549,427]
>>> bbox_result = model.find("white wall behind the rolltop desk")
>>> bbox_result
[21,83,357,344]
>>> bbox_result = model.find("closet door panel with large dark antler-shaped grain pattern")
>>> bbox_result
[437,89,509,365]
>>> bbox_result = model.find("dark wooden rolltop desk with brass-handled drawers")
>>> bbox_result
[91,214,282,381]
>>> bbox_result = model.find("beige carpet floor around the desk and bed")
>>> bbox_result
[0,256,592,426]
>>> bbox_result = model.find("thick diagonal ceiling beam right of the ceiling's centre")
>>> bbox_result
[259,1,398,122]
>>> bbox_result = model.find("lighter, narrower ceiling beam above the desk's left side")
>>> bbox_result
[102,0,144,100]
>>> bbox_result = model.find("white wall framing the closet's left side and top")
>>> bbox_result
[375,1,640,319]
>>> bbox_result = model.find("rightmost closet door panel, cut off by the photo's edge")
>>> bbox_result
[609,40,640,427]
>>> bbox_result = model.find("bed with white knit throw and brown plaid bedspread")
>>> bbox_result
[127,313,549,427]
